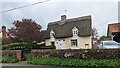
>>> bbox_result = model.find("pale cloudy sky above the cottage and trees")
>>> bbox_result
[0,0,119,35]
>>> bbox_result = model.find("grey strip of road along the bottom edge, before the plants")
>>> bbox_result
[1,64,80,68]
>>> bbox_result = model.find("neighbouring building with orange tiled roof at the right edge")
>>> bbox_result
[107,23,120,42]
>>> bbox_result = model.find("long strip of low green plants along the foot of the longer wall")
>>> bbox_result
[29,58,120,68]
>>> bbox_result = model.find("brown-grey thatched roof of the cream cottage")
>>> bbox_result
[45,16,91,39]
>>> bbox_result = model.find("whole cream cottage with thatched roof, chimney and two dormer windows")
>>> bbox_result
[43,15,92,49]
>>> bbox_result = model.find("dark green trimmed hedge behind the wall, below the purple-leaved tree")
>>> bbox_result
[2,42,55,50]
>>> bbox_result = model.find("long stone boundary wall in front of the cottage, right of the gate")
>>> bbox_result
[32,49,120,59]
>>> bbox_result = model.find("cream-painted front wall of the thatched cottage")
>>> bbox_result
[45,36,92,49]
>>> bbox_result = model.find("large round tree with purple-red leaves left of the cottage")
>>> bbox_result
[8,19,42,42]
